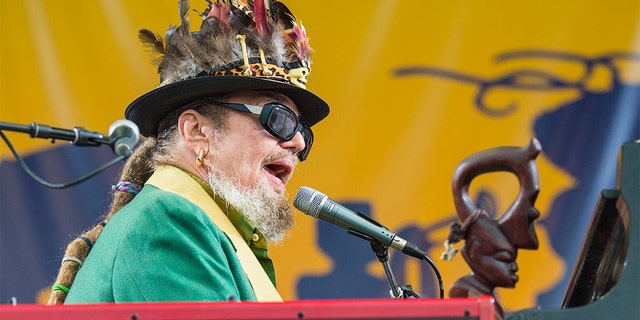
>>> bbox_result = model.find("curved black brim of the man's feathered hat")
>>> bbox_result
[125,76,329,137]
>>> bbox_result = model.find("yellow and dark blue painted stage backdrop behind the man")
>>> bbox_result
[0,0,640,310]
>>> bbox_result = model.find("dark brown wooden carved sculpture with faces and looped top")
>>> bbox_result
[442,139,541,319]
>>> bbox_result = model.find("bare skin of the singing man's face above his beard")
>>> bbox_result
[212,91,304,195]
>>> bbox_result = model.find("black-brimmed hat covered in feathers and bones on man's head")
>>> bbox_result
[125,0,329,136]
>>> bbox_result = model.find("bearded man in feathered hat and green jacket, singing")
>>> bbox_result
[49,0,329,304]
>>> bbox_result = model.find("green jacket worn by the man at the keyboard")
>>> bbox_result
[65,171,275,304]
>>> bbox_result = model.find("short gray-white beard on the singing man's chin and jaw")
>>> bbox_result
[207,169,294,244]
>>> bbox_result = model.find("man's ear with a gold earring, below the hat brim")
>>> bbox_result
[178,109,214,154]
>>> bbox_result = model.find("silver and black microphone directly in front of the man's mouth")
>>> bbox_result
[293,186,426,259]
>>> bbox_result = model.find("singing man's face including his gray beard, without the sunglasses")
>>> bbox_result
[208,92,305,243]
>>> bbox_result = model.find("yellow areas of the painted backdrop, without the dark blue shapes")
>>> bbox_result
[0,0,640,310]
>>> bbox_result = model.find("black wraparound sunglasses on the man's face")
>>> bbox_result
[216,102,313,162]
